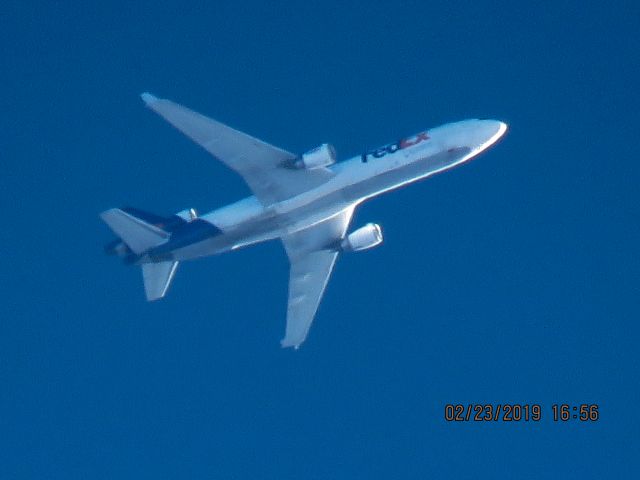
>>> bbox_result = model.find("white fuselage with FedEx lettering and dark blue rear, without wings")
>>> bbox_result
[144,120,507,263]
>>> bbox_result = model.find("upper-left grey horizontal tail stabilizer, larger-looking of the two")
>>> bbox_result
[100,208,169,255]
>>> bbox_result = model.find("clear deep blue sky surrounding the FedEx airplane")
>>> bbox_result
[0,0,640,479]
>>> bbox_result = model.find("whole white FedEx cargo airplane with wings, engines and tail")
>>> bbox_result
[100,92,507,349]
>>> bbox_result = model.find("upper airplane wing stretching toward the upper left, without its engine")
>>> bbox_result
[141,93,334,206]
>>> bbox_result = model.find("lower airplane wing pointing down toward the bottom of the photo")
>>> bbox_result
[281,205,355,348]
